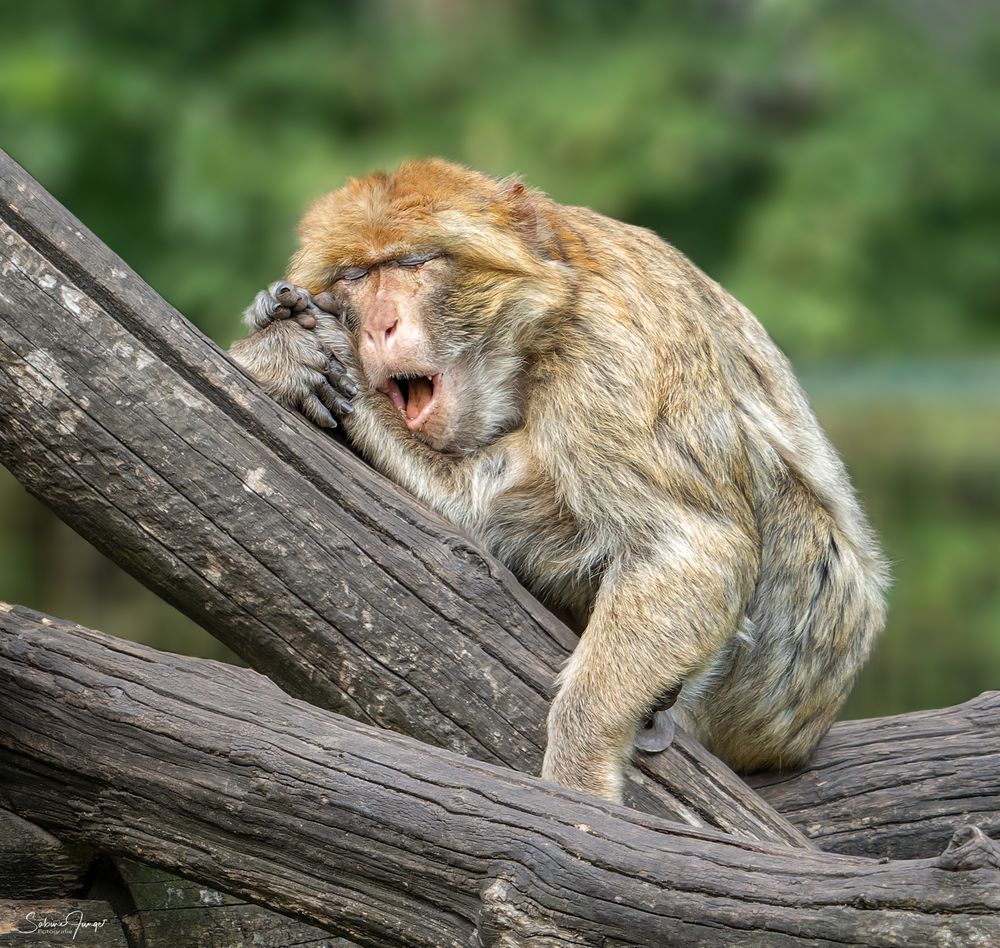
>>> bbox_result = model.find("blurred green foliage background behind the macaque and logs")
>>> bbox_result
[0,0,1000,716]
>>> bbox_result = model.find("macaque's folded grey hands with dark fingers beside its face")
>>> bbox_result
[229,281,358,428]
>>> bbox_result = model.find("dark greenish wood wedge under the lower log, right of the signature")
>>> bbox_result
[115,859,353,948]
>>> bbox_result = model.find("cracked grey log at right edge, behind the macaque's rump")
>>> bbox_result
[749,691,1000,859]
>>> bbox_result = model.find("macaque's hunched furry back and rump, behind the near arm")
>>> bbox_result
[544,208,888,771]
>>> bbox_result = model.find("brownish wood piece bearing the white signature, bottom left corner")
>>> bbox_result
[0,899,129,948]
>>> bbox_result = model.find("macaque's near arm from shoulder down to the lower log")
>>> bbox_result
[529,339,760,799]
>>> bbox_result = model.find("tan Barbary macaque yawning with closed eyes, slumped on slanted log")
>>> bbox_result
[232,159,887,800]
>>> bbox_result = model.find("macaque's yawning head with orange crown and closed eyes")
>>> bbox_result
[289,162,572,452]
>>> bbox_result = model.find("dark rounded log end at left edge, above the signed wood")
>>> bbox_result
[0,809,90,899]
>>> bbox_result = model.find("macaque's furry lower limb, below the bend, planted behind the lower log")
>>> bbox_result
[542,529,756,802]
